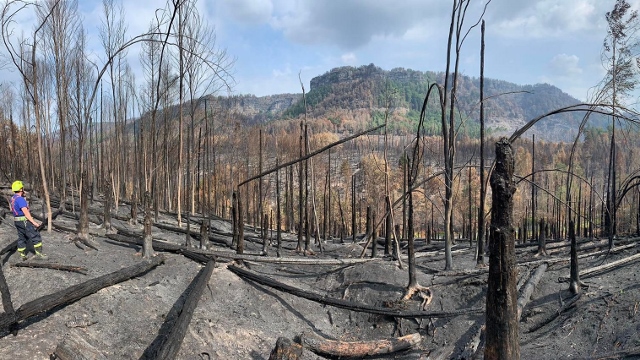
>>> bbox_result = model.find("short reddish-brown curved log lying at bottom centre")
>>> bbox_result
[300,332,422,358]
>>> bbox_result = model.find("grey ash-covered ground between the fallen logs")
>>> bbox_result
[0,195,640,360]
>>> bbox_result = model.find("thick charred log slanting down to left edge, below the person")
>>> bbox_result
[0,256,164,330]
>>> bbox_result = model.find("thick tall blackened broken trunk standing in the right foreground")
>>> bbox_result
[484,138,520,360]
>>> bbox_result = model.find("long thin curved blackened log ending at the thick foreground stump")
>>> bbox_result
[227,265,484,318]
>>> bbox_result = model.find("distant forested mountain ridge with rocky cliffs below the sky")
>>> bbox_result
[218,64,606,141]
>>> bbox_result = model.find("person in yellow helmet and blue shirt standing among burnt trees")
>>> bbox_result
[11,180,47,261]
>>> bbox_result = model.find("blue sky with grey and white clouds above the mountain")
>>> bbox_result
[6,0,640,100]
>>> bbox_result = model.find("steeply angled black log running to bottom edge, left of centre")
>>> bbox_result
[143,260,215,359]
